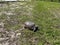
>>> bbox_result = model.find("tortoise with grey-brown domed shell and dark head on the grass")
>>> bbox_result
[24,21,38,32]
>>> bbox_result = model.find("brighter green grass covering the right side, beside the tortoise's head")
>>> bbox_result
[33,1,60,45]
